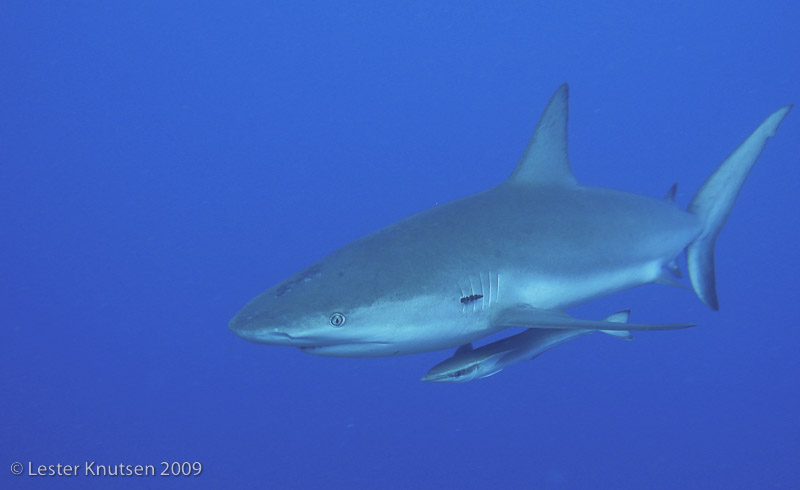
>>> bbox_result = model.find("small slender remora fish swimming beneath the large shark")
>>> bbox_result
[422,310,633,383]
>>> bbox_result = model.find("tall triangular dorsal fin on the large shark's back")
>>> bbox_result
[508,83,577,185]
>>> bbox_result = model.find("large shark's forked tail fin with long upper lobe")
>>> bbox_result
[686,105,792,310]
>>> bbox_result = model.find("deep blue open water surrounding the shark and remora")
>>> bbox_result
[0,0,800,489]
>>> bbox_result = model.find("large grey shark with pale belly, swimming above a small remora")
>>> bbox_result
[228,84,791,357]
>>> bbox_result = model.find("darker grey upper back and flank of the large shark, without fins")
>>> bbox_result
[256,183,699,311]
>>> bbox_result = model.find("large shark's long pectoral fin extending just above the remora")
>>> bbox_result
[492,304,694,331]
